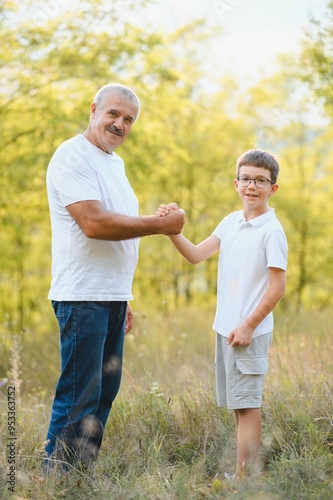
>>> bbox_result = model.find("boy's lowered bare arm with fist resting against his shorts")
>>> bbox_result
[228,267,286,347]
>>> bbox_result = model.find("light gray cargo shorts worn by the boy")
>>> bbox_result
[215,332,273,410]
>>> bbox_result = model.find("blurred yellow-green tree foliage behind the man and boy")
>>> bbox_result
[0,0,333,387]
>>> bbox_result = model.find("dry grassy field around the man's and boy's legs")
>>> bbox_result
[0,309,333,500]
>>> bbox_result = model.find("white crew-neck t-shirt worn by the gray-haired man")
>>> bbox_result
[46,134,139,301]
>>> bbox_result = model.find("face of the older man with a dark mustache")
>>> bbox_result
[89,93,138,154]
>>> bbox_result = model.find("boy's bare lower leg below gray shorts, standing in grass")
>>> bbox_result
[235,408,261,477]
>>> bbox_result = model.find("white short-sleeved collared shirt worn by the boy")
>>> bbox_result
[213,209,288,337]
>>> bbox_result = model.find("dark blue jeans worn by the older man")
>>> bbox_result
[45,301,127,466]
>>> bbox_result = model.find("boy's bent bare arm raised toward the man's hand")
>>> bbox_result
[169,234,220,264]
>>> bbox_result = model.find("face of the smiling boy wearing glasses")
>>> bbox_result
[234,165,279,220]
